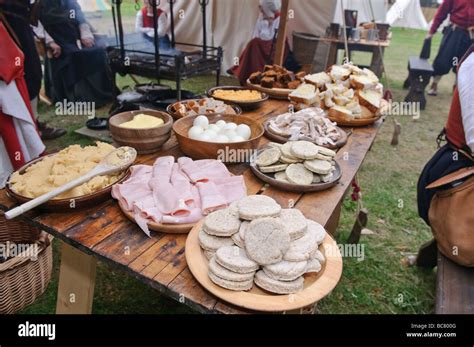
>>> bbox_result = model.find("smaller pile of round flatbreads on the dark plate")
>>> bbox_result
[255,141,336,185]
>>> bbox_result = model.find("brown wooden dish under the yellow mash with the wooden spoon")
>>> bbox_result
[5,153,130,212]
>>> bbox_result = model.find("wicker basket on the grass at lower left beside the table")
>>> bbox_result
[0,231,53,314]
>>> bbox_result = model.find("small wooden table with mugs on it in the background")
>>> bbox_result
[319,37,390,78]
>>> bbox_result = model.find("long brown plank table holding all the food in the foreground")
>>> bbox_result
[0,100,382,313]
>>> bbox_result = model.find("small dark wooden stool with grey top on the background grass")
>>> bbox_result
[404,56,434,110]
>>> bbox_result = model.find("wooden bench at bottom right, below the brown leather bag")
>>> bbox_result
[417,240,474,314]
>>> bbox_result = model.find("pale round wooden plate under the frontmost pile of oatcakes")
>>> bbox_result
[185,221,342,312]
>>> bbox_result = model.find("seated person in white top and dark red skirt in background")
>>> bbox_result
[227,0,289,85]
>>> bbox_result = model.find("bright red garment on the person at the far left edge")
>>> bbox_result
[0,22,39,170]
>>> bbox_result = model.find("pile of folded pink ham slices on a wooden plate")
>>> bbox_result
[112,157,246,236]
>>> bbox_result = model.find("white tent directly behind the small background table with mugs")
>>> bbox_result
[334,0,388,24]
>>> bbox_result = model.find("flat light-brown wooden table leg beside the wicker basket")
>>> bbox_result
[56,243,97,314]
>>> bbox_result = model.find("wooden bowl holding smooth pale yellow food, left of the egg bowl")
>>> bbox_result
[109,110,173,154]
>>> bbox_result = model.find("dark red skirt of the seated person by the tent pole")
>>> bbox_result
[229,38,290,85]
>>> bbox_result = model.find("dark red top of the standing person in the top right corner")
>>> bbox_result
[430,0,474,34]
